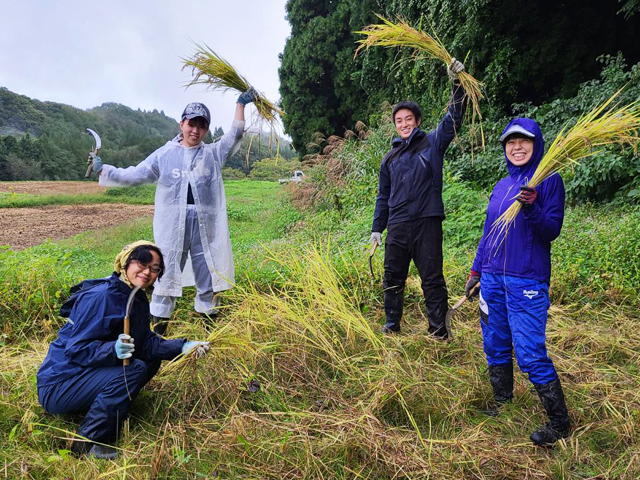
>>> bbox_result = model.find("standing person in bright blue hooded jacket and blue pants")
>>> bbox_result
[465,118,570,445]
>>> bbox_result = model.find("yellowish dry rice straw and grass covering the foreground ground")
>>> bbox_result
[0,248,640,480]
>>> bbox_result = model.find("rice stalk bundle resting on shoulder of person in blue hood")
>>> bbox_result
[492,89,640,239]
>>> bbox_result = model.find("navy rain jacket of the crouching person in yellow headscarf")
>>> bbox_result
[38,273,185,387]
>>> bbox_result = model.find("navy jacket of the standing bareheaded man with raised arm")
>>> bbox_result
[371,84,466,233]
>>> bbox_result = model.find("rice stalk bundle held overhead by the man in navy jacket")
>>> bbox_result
[354,15,484,148]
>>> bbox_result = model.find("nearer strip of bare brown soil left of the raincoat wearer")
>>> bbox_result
[0,202,153,250]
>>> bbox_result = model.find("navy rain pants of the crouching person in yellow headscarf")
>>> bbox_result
[38,359,160,443]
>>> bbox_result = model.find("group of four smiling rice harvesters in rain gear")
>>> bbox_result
[37,59,570,458]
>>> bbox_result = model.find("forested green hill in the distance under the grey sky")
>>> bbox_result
[0,87,294,180]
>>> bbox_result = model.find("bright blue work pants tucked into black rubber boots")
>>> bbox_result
[480,273,558,385]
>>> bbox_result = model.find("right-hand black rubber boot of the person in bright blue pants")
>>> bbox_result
[529,378,571,447]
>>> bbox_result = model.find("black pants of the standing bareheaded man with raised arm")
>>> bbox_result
[383,217,448,336]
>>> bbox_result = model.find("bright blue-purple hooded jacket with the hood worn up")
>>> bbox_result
[472,118,564,283]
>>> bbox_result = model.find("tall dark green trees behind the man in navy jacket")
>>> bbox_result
[279,0,640,154]
